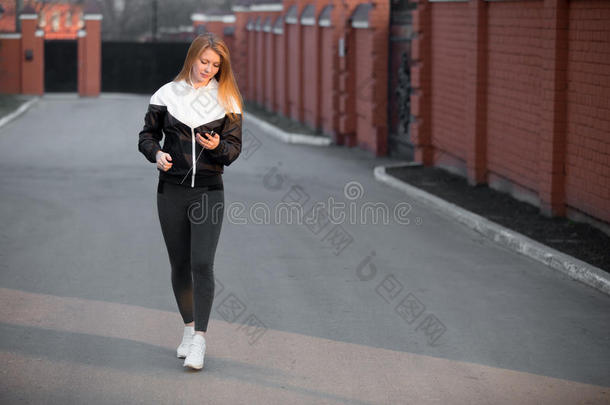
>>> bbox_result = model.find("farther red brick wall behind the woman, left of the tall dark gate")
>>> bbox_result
[230,0,389,155]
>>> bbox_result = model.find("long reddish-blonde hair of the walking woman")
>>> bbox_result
[174,32,244,121]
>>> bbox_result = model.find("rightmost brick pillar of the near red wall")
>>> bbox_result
[538,0,568,216]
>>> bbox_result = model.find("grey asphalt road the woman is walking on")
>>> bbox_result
[0,94,610,404]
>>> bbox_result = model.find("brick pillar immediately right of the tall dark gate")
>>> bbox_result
[410,0,434,166]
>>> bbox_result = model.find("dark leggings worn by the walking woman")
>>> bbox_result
[157,180,224,332]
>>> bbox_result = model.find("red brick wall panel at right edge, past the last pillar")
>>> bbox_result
[565,0,610,222]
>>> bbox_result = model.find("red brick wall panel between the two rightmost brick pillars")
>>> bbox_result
[487,1,544,192]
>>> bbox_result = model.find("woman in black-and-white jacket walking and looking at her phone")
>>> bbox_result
[138,33,243,369]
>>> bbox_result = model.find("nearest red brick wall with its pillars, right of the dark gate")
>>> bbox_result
[411,0,610,223]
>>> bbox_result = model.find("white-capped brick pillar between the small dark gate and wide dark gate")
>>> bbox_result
[78,13,102,97]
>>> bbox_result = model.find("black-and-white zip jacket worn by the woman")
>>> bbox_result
[138,78,242,187]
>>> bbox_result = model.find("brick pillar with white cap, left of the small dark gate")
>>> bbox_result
[19,12,44,95]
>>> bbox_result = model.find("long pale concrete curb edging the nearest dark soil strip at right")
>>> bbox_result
[374,164,610,295]
